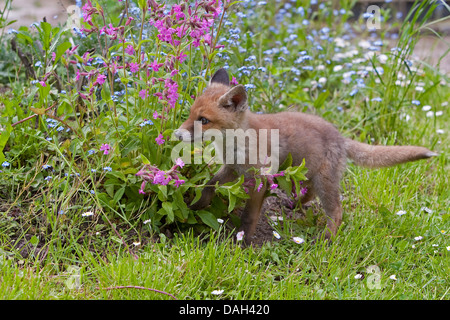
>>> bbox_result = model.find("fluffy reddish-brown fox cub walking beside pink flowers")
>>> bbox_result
[175,69,437,244]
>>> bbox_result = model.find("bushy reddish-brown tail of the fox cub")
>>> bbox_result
[345,139,438,168]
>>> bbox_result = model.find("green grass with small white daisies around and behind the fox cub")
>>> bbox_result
[0,1,450,300]
